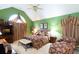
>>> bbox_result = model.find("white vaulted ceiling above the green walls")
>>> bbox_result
[0,4,79,21]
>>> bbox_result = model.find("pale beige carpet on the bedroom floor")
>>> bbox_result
[11,41,51,54]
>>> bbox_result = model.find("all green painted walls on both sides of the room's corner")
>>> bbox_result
[0,7,79,35]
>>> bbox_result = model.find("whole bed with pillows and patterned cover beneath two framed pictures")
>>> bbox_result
[22,29,49,49]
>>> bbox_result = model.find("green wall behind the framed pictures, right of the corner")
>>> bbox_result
[33,12,79,33]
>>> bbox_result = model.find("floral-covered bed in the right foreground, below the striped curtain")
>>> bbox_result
[49,37,76,54]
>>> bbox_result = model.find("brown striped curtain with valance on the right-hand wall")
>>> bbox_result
[61,16,79,44]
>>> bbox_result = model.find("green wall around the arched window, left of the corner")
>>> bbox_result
[0,7,32,34]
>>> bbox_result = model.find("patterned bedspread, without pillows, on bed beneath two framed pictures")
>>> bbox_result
[24,35,49,49]
